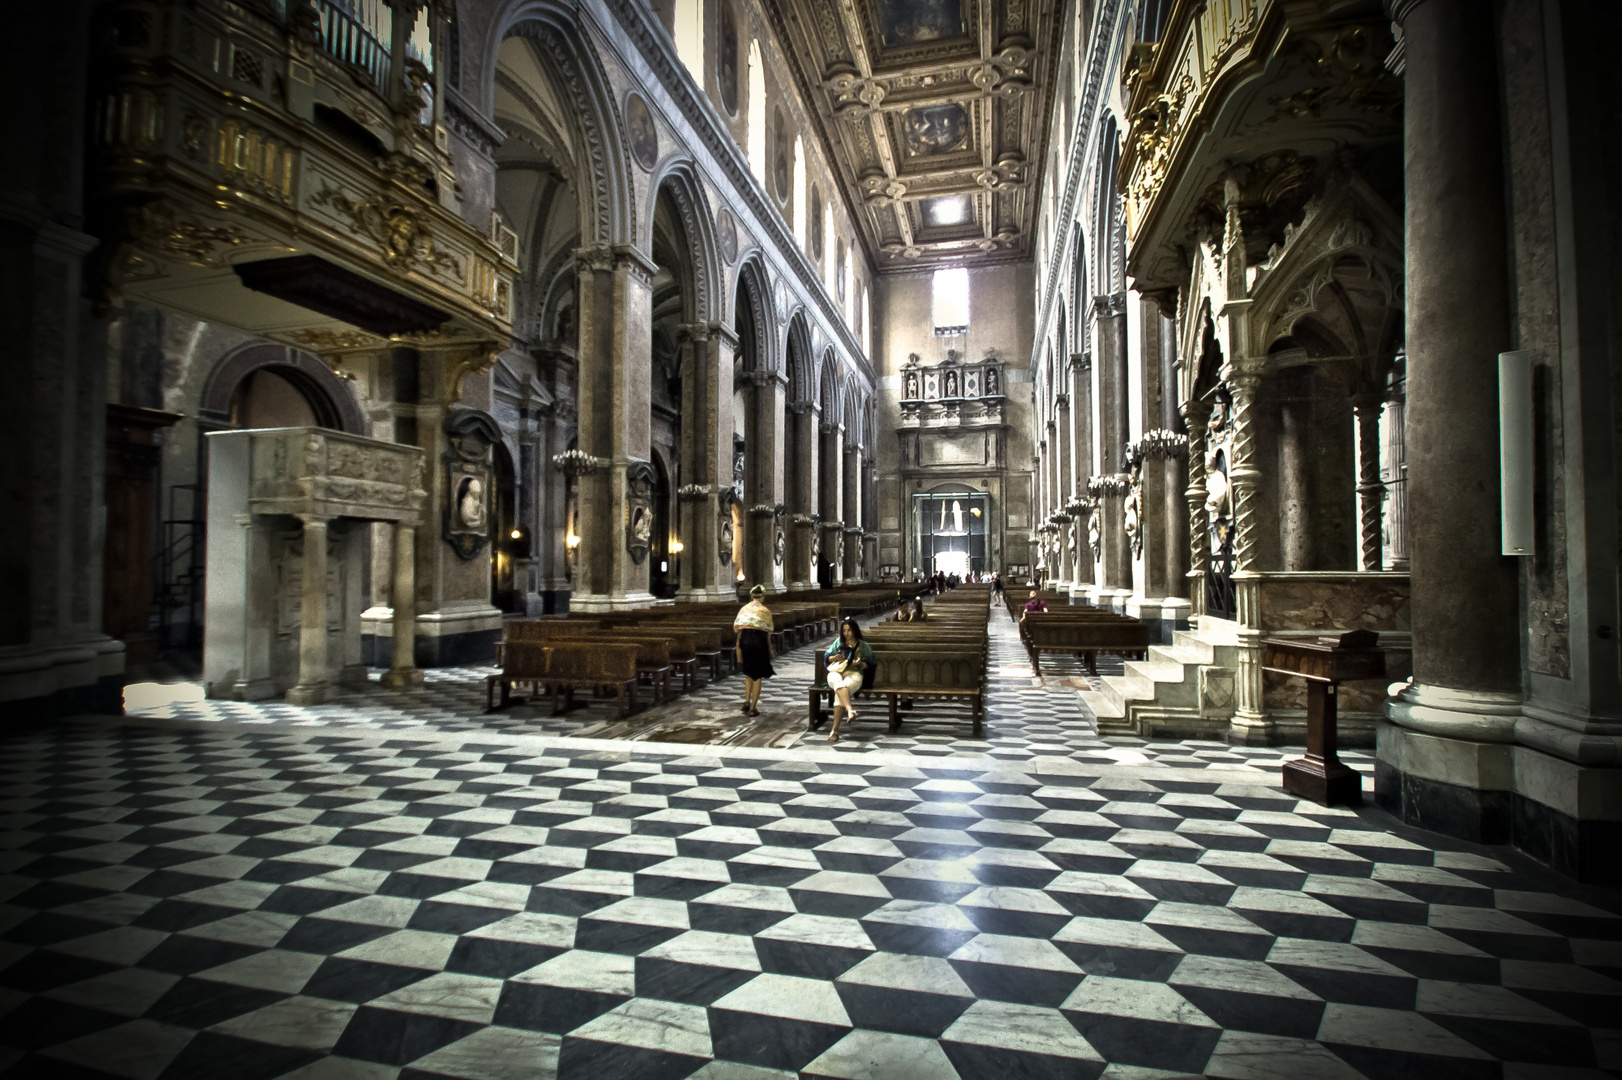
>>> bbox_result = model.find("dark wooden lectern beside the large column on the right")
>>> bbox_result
[1262,631,1385,806]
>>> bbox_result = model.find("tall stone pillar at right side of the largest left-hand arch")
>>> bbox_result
[569,245,657,611]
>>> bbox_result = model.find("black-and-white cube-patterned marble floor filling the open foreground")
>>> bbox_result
[0,720,1622,1080]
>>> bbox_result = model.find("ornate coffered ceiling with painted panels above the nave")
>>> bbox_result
[766,0,1058,272]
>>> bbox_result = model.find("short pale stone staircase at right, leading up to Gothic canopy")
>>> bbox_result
[1079,623,1239,739]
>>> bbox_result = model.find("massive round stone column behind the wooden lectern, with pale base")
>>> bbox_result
[1375,0,1521,843]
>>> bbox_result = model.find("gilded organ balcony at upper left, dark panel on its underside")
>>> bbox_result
[89,0,517,357]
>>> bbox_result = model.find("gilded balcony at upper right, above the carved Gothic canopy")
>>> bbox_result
[1119,0,1401,290]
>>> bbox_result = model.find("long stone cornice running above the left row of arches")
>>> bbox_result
[607,0,878,389]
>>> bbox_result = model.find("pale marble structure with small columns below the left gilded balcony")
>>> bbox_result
[203,428,427,704]
